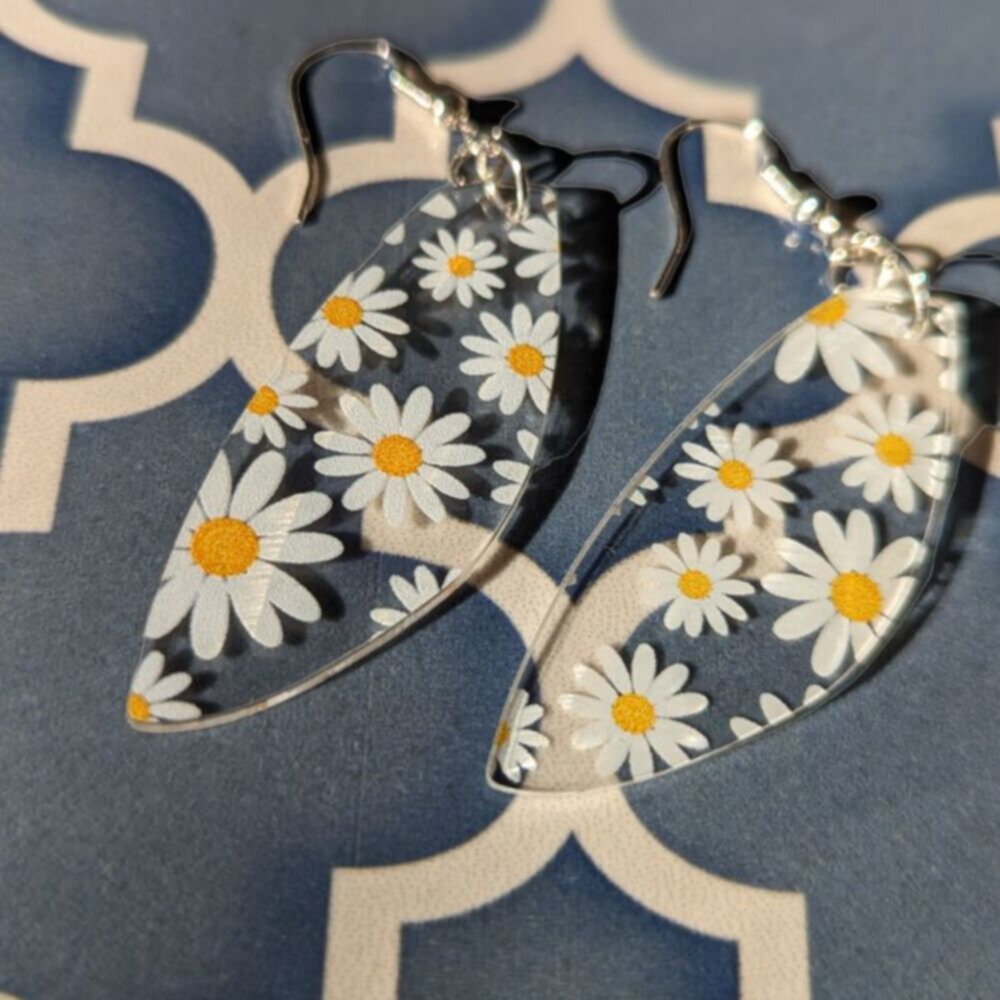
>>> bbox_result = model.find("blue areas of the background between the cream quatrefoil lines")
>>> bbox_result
[0,0,1000,1000]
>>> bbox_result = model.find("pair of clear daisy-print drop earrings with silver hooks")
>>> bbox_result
[121,40,965,790]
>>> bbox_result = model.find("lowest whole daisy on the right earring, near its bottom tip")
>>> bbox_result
[559,643,708,779]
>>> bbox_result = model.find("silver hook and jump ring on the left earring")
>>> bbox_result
[288,38,528,223]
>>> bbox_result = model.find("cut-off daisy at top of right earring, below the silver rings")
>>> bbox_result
[774,288,909,392]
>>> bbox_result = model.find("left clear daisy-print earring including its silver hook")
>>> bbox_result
[125,40,561,728]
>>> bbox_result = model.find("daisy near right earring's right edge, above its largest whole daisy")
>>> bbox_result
[831,395,952,514]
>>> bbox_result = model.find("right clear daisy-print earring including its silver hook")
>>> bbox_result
[487,121,971,792]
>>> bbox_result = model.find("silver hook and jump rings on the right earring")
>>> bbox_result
[650,118,930,331]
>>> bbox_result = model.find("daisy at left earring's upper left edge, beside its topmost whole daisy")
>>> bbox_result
[292,266,410,372]
